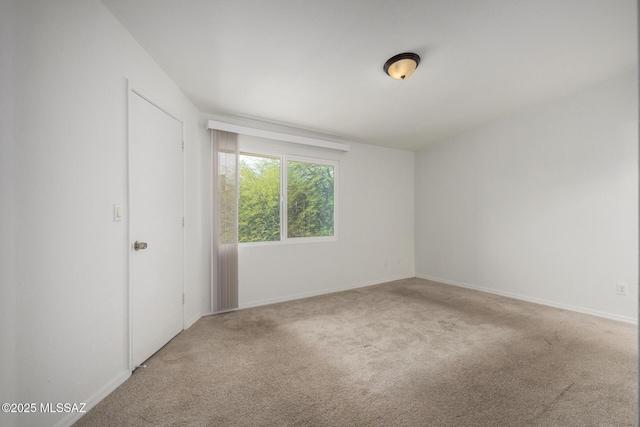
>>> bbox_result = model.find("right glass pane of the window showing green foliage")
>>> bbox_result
[287,160,334,238]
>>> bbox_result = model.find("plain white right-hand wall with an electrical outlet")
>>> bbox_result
[416,70,638,322]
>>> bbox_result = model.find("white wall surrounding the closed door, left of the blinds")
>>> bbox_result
[6,0,209,426]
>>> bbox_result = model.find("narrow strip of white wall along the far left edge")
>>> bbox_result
[0,1,17,427]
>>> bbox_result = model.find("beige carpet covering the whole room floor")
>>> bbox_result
[76,279,637,427]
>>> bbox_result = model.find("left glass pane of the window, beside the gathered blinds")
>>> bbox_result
[238,154,280,243]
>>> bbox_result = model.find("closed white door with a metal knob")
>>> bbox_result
[129,91,184,368]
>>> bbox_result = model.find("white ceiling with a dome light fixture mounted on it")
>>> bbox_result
[103,0,638,150]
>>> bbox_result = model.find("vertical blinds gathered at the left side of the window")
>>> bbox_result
[211,130,238,312]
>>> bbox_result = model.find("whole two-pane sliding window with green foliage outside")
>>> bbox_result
[238,153,337,243]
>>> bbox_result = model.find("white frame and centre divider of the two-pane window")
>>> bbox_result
[238,149,340,246]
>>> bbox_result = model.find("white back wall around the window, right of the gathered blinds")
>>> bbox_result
[239,136,414,307]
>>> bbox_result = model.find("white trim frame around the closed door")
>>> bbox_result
[126,79,186,372]
